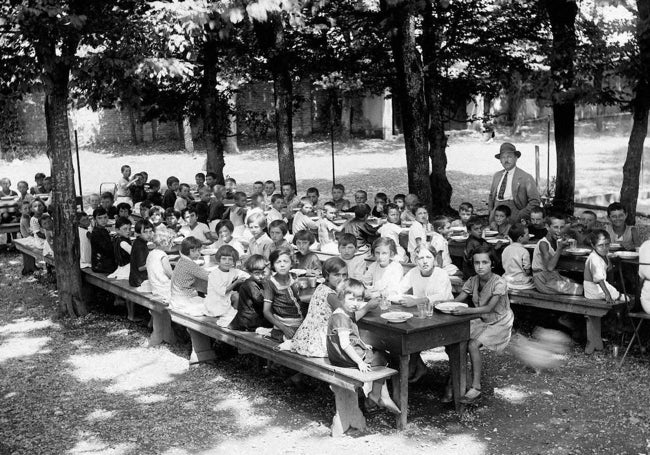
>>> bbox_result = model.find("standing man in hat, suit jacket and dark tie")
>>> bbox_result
[488,142,540,223]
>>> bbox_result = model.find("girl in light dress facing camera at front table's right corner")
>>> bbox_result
[453,246,514,404]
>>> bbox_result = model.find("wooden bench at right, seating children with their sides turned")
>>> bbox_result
[508,290,625,354]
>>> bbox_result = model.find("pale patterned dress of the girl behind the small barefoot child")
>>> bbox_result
[292,284,334,357]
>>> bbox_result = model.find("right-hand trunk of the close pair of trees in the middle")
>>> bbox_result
[422,1,450,214]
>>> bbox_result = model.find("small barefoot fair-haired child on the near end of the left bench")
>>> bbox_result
[327,279,400,414]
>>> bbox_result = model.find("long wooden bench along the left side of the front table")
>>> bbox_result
[18,237,397,436]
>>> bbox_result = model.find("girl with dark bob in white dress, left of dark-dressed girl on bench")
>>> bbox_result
[203,245,250,327]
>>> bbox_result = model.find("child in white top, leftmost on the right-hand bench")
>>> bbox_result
[501,223,535,290]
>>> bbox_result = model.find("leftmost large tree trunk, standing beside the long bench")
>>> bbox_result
[44,63,88,317]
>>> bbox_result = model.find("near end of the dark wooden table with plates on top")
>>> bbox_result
[358,305,478,429]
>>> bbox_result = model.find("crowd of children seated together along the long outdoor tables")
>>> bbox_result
[13,166,639,412]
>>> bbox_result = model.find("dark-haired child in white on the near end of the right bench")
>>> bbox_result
[583,229,627,304]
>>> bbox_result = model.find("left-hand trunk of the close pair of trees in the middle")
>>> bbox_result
[381,0,432,209]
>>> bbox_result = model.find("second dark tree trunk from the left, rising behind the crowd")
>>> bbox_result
[201,38,226,185]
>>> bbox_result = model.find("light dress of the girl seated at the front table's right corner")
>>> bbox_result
[463,274,515,352]
